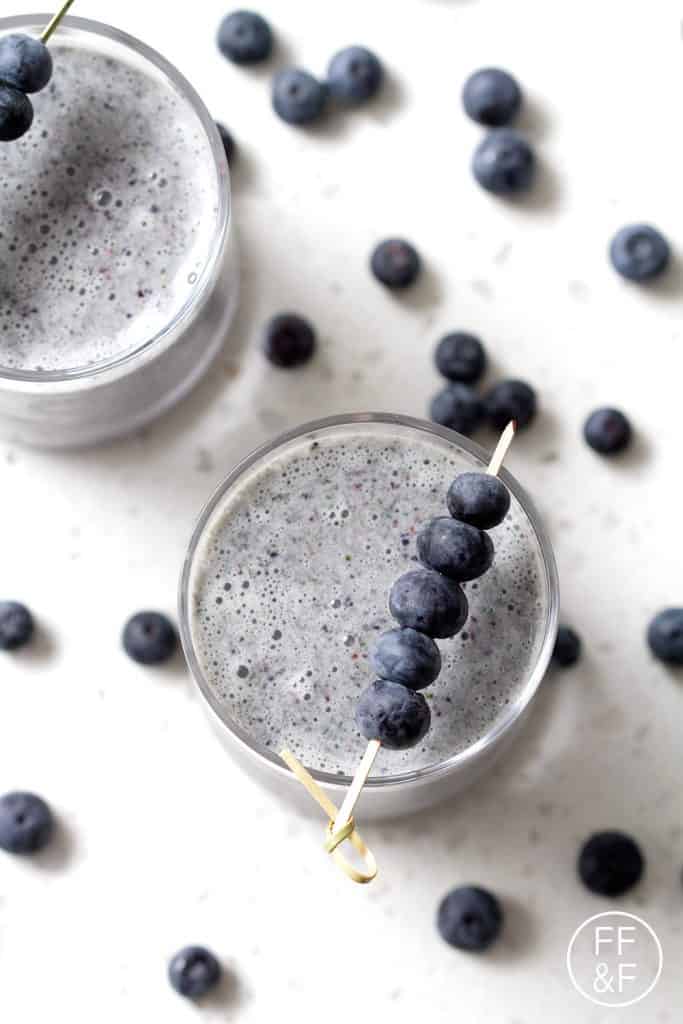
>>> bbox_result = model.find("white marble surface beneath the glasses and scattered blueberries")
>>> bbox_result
[0,0,683,1024]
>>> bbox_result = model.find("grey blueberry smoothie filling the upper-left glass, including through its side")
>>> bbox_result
[0,18,234,443]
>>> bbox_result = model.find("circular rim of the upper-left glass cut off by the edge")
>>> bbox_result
[0,13,231,393]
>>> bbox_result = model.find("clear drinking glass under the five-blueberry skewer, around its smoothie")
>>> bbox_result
[179,413,559,818]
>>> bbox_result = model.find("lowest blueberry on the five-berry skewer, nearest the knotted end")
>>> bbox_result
[355,679,431,751]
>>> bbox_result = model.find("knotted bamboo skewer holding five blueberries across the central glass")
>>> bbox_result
[281,421,517,882]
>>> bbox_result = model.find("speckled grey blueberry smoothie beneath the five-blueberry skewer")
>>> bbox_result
[185,413,554,776]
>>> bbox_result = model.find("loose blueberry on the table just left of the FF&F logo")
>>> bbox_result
[436,886,503,952]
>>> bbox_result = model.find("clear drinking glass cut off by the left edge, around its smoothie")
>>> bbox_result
[0,14,239,447]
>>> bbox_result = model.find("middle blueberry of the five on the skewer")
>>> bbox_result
[389,569,467,637]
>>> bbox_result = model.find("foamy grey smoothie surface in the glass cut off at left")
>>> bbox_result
[0,41,218,371]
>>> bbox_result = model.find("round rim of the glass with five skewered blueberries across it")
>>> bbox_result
[178,413,559,790]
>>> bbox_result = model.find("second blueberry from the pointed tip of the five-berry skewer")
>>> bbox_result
[417,516,494,583]
